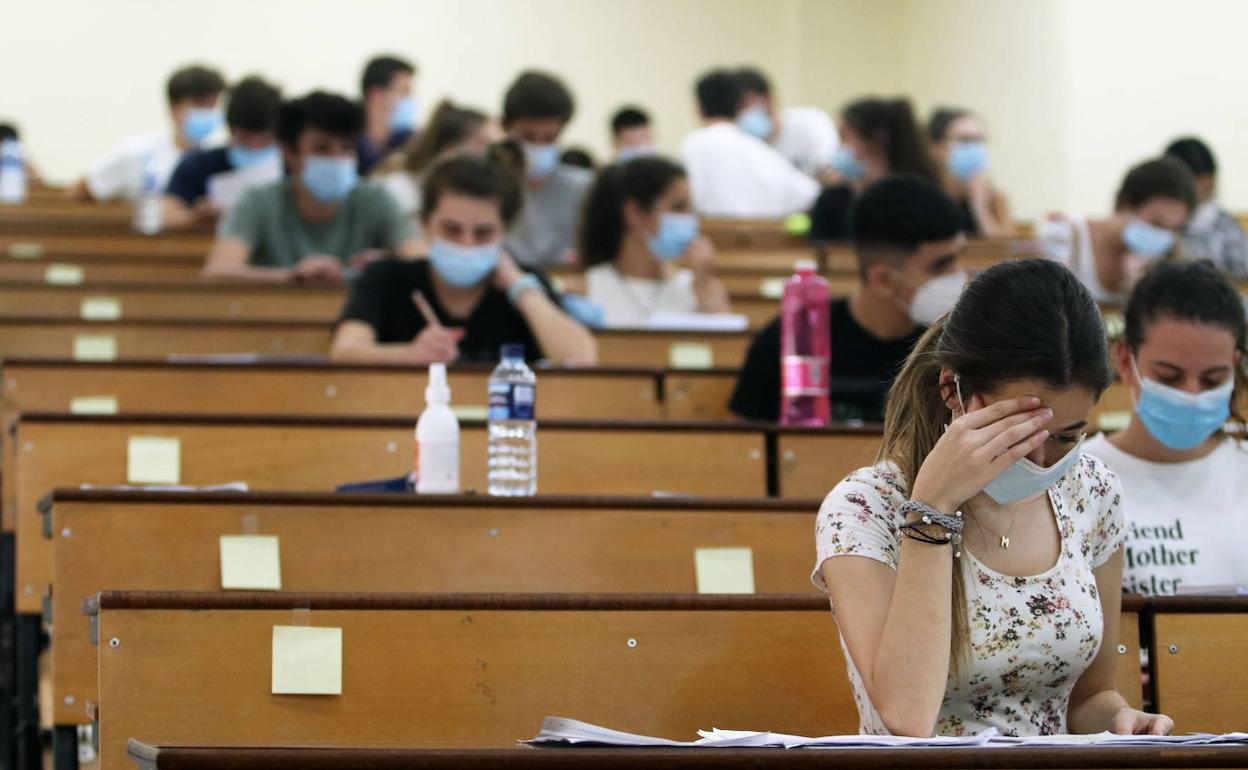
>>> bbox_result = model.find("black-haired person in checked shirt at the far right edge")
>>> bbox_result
[1166,136,1248,278]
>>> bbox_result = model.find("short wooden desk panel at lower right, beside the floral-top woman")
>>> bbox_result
[1149,594,1248,733]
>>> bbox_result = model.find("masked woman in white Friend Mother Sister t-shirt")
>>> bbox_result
[1087,261,1248,595]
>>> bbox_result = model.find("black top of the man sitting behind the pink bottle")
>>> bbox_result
[729,298,924,423]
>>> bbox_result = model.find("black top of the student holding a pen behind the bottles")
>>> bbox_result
[339,258,559,362]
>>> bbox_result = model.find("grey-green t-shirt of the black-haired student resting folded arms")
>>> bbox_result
[217,180,411,267]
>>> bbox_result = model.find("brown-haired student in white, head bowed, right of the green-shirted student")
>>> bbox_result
[377,100,493,216]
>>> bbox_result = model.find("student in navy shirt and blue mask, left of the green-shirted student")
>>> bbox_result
[162,77,282,230]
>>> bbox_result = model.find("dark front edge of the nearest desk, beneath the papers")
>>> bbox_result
[127,738,1248,770]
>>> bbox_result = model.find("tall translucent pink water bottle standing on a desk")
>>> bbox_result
[780,260,832,426]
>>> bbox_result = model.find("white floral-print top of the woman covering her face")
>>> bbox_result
[811,454,1126,735]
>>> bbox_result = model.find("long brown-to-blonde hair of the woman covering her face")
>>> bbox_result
[877,260,1113,671]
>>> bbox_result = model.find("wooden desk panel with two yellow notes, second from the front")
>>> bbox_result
[45,489,823,725]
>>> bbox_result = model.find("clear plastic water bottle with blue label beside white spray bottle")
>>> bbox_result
[487,344,538,497]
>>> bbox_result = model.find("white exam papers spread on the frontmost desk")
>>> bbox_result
[523,716,1248,749]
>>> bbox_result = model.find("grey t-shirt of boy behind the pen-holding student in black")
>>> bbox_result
[507,165,594,267]
